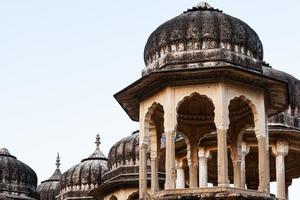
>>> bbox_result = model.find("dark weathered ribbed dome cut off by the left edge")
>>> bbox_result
[0,148,38,199]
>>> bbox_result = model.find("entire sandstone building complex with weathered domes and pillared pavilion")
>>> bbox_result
[0,2,300,200]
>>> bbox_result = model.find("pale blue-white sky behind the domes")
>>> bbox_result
[0,0,300,200]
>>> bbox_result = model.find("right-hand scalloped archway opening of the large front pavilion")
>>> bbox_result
[228,96,258,189]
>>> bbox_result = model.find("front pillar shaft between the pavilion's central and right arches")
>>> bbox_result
[217,128,229,187]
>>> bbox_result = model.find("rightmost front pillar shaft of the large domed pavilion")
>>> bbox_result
[257,137,270,193]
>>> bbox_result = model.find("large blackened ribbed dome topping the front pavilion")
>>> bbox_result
[143,3,263,75]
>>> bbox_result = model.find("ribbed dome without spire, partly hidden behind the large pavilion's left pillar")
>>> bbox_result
[108,131,143,170]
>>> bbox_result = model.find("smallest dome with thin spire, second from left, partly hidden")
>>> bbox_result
[37,155,62,200]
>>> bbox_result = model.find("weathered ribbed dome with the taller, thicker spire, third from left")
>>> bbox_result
[60,135,107,198]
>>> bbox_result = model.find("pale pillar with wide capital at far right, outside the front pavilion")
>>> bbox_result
[272,141,289,200]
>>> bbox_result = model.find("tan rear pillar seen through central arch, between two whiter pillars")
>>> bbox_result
[188,143,198,188]
